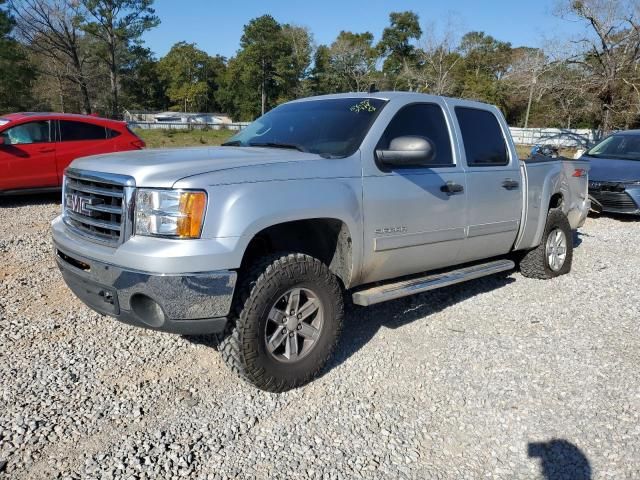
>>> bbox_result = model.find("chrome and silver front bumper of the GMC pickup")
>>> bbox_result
[54,242,237,335]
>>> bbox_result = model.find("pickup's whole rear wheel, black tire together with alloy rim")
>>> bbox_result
[520,209,573,279]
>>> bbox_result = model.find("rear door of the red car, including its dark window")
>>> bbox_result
[56,120,113,178]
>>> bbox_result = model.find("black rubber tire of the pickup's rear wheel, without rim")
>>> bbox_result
[520,208,573,280]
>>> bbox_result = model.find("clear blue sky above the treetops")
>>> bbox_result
[143,0,582,57]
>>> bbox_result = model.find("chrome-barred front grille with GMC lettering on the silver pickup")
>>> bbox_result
[63,170,134,245]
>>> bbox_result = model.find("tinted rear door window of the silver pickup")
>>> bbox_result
[455,107,509,167]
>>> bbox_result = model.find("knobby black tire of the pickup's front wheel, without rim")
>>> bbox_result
[219,253,344,392]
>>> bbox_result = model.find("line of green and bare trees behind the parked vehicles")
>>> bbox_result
[6,5,640,131]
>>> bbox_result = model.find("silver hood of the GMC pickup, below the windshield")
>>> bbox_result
[70,147,321,188]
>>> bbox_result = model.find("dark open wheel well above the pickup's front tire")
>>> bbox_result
[241,218,353,288]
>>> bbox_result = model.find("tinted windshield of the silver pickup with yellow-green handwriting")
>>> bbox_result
[223,98,386,157]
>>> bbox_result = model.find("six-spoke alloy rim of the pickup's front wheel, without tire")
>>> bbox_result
[264,288,324,362]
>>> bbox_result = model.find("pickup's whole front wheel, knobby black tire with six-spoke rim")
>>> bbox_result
[220,253,344,392]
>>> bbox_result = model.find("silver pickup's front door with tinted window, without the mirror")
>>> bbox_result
[361,99,467,283]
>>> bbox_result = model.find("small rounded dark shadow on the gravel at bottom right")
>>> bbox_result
[527,439,591,480]
